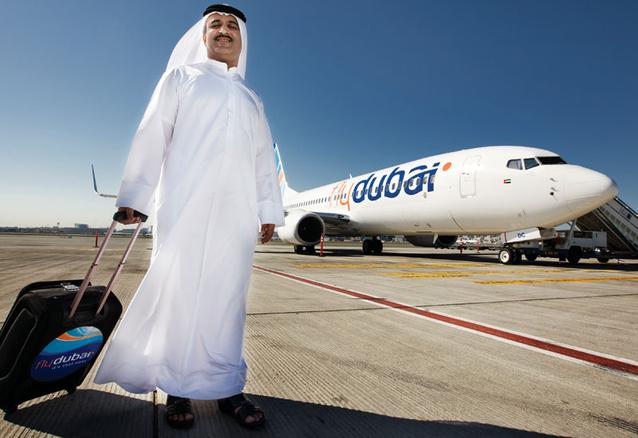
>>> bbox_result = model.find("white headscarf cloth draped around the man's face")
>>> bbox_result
[165,11,248,79]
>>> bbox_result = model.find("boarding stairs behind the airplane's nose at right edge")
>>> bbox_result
[576,197,638,258]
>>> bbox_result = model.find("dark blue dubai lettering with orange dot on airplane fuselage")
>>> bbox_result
[352,162,452,203]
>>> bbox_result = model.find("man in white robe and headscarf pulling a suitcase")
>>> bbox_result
[95,5,283,428]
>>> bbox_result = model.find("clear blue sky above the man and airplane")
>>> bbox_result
[0,0,638,226]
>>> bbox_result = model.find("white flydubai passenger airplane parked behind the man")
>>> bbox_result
[275,145,618,254]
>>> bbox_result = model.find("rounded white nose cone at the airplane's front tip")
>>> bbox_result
[565,168,618,214]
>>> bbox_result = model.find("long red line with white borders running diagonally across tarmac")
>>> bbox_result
[253,265,638,380]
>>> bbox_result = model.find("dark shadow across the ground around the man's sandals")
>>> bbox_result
[5,389,564,438]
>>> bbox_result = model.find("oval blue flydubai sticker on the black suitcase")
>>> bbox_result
[31,326,104,382]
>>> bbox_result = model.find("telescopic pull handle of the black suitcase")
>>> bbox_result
[68,210,148,320]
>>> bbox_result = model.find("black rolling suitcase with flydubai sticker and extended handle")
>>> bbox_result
[0,212,146,413]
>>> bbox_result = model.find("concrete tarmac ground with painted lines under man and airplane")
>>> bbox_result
[0,234,638,438]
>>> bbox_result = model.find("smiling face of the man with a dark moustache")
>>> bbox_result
[204,13,241,68]
